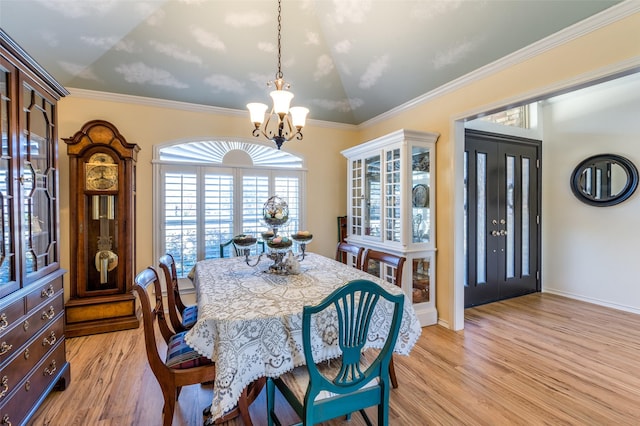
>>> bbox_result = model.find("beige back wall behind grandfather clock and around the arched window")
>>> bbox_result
[58,97,356,298]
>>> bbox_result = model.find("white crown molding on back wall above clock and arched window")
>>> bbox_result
[66,87,358,131]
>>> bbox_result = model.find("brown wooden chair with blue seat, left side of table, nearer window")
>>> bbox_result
[159,253,198,333]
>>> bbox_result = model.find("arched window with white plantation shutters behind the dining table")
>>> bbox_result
[153,141,305,277]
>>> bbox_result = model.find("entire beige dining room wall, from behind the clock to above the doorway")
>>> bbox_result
[59,13,640,323]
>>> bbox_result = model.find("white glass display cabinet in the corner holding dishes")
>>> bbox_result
[342,130,439,326]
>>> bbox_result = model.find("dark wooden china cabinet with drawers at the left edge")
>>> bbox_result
[0,29,70,425]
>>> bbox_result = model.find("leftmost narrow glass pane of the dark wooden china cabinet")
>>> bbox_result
[0,68,16,284]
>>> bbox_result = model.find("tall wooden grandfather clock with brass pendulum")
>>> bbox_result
[63,120,140,337]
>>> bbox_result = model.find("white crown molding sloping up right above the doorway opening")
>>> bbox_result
[358,0,640,129]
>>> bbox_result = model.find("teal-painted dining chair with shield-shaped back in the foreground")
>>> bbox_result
[267,280,404,426]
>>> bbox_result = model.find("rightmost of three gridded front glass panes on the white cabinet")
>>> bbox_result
[384,148,401,242]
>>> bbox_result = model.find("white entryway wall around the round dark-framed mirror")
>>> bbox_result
[542,74,640,313]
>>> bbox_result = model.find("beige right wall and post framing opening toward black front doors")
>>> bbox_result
[361,13,640,324]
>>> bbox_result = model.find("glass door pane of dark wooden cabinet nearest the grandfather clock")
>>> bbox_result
[21,86,58,274]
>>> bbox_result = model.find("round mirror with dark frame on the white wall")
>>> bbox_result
[571,154,638,207]
